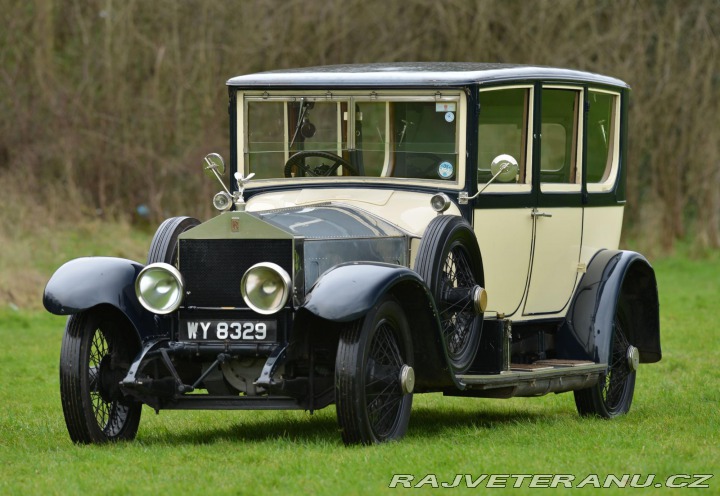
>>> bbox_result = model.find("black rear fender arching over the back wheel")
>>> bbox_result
[557,250,662,363]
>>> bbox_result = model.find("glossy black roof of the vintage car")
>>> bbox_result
[227,62,629,88]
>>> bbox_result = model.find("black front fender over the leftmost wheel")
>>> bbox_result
[43,257,159,341]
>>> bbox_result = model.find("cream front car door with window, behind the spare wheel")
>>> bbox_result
[473,84,535,317]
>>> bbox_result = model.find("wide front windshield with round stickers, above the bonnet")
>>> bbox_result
[238,91,461,182]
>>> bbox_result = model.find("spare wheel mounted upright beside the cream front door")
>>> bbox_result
[415,215,484,374]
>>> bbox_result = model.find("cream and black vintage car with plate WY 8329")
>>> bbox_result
[44,63,661,444]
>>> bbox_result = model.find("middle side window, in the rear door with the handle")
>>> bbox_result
[540,88,582,189]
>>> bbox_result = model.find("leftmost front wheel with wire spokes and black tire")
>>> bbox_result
[60,310,142,444]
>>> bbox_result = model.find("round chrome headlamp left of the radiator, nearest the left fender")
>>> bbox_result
[135,263,185,315]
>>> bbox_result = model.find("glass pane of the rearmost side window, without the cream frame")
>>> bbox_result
[586,91,617,183]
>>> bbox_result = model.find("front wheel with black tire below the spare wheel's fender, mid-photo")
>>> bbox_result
[335,296,413,445]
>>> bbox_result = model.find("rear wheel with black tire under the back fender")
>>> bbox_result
[574,304,636,419]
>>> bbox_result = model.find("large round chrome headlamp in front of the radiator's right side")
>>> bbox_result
[240,262,291,315]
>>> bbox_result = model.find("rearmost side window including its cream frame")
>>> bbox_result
[586,90,619,191]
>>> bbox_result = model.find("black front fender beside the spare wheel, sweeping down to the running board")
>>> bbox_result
[301,262,459,392]
